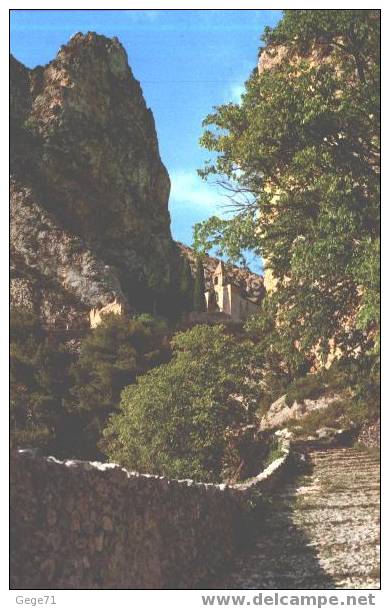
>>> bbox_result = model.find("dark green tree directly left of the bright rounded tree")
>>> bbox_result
[68,315,168,458]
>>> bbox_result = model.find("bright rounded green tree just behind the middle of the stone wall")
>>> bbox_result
[101,325,260,480]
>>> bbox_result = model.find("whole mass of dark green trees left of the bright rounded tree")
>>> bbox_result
[10,309,170,458]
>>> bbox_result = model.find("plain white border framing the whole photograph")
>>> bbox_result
[0,0,390,609]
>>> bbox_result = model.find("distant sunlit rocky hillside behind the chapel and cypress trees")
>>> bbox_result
[177,242,265,300]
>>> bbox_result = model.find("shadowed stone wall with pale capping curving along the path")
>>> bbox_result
[11,436,289,589]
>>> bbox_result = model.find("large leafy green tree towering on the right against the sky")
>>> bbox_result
[195,10,380,358]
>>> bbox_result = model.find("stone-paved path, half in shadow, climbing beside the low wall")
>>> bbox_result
[212,448,379,590]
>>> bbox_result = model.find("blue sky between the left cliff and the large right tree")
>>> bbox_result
[11,10,281,270]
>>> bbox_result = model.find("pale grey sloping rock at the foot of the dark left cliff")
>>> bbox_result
[11,181,124,326]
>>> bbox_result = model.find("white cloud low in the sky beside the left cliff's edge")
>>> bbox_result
[170,170,222,211]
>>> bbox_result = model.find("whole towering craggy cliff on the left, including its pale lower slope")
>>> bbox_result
[11,33,179,324]
